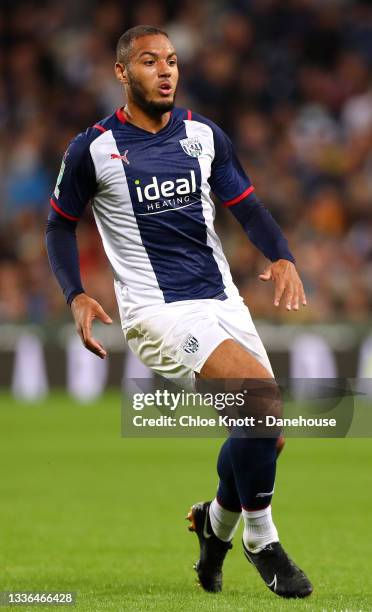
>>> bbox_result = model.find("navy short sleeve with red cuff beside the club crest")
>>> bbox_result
[209,124,254,206]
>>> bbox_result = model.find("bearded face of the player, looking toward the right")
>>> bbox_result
[117,34,178,115]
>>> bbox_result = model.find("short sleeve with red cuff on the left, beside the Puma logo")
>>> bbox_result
[50,133,97,221]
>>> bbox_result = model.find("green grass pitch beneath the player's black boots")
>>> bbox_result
[0,392,372,612]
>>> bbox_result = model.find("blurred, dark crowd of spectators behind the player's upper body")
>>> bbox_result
[0,0,372,323]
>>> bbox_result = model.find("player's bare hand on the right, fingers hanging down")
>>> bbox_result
[259,259,307,310]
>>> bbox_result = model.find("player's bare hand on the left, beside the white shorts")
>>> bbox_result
[71,293,112,359]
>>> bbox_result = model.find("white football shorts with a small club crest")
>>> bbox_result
[124,296,273,380]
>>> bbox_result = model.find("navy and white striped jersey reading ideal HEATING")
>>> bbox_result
[51,108,253,316]
